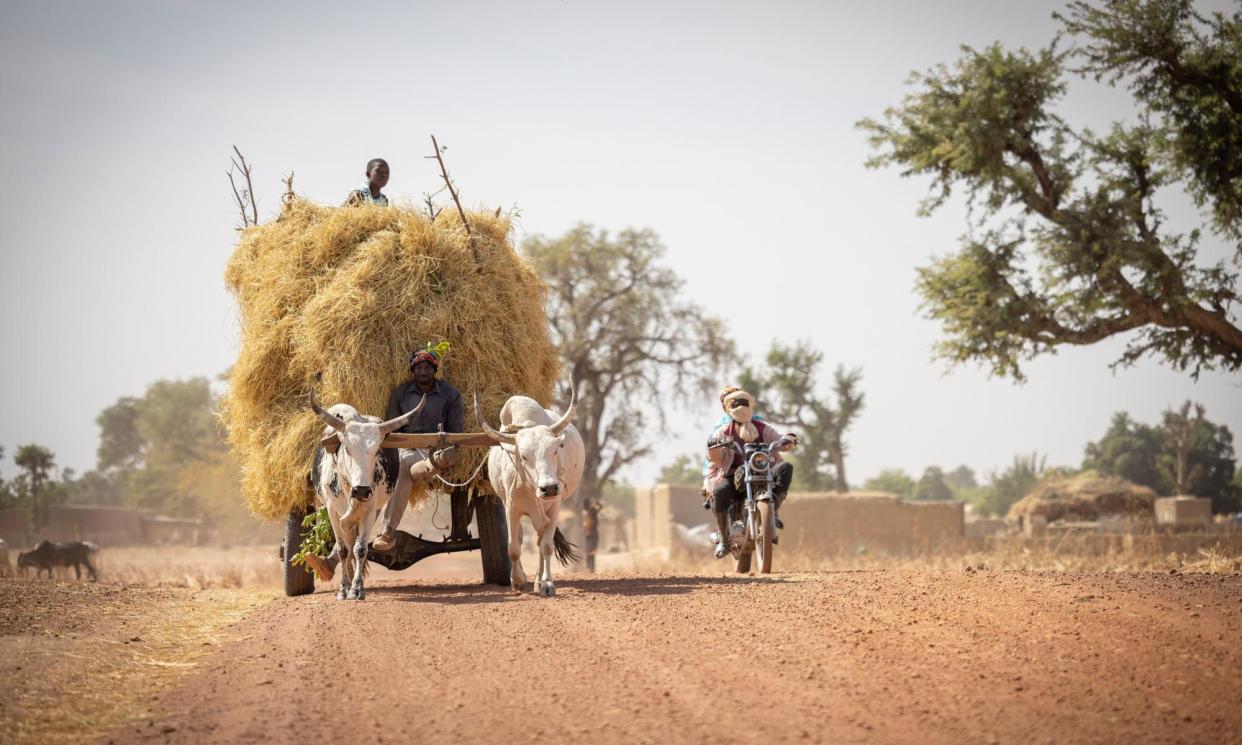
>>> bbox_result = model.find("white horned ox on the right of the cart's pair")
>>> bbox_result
[474,394,586,597]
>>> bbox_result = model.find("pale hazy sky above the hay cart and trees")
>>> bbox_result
[0,0,1242,494]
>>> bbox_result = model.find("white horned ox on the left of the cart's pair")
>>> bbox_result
[309,392,427,600]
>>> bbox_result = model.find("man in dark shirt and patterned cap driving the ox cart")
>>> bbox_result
[306,341,466,582]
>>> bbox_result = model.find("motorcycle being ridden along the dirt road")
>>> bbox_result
[709,435,797,574]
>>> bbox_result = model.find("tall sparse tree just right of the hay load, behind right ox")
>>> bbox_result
[523,225,733,499]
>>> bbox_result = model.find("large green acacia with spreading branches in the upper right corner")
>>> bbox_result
[861,0,1242,380]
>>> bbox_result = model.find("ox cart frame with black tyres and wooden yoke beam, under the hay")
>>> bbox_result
[281,432,512,596]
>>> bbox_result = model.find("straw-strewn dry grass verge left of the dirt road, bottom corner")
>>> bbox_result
[0,580,274,745]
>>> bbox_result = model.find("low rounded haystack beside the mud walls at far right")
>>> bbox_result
[1009,471,1156,523]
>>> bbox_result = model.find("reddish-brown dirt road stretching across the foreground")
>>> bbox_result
[111,571,1242,744]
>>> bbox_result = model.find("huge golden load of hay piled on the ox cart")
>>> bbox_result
[222,200,559,519]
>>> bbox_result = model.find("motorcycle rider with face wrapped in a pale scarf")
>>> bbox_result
[703,385,797,559]
